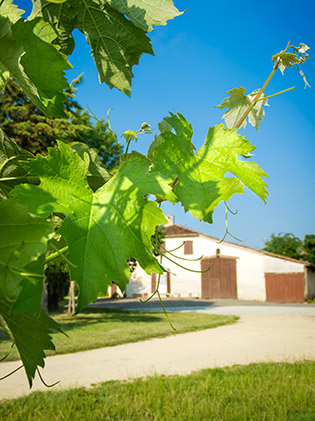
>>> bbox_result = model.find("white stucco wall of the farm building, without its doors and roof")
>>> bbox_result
[127,230,308,301]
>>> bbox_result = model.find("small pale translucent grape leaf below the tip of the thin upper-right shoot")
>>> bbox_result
[216,87,269,131]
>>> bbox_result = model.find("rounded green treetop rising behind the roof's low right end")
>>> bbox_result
[263,233,304,259]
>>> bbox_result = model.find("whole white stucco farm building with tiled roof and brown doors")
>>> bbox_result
[126,219,315,302]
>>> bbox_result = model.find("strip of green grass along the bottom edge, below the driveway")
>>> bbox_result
[0,361,315,421]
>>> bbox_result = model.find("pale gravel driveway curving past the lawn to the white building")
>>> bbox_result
[0,300,315,399]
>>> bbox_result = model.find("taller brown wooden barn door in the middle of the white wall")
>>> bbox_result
[201,257,237,298]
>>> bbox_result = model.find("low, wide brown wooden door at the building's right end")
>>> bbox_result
[265,273,304,303]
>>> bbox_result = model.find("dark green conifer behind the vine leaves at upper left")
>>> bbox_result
[0,76,121,169]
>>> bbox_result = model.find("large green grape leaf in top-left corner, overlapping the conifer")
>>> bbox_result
[0,0,71,117]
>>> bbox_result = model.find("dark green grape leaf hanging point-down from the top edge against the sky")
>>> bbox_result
[31,0,153,96]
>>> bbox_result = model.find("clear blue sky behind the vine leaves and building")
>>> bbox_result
[15,0,315,248]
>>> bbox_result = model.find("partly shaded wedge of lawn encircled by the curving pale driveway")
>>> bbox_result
[0,308,238,361]
